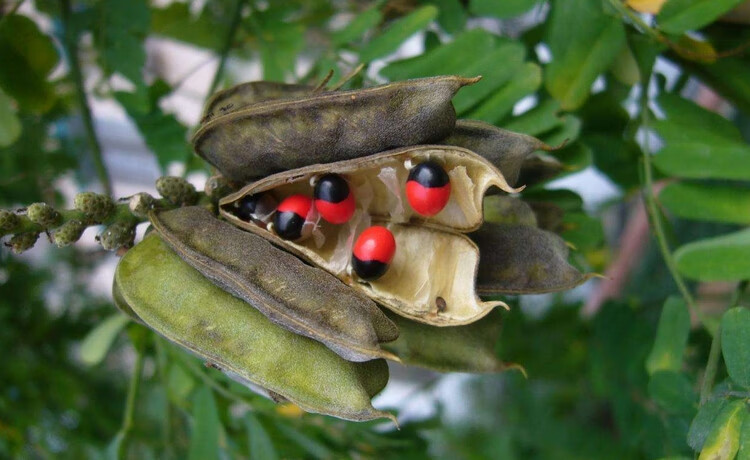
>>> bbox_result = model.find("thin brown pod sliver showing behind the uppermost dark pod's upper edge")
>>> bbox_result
[200,81,315,123]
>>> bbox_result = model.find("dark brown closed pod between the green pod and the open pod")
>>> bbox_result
[150,206,398,361]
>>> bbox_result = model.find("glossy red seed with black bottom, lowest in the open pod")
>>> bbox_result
[352,225,396,281]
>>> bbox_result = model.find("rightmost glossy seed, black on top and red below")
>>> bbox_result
[406,161,451,217]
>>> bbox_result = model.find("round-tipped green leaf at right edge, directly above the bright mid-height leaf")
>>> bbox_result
[659,182,750,225]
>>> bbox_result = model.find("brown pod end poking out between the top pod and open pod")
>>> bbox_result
[440,120,554,185]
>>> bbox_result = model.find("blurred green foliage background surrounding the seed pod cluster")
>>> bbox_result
[0,0,750,459]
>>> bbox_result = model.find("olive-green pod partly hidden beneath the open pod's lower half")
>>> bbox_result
[385,311,517,373]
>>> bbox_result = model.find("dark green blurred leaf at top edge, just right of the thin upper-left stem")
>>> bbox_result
[94,0,150,85]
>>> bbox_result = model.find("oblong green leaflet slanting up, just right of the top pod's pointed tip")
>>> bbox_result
[467,62,542,124]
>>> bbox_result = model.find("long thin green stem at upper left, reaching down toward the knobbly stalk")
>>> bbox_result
[61,0,112,195]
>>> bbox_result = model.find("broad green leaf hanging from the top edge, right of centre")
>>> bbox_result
[545,0,625,110]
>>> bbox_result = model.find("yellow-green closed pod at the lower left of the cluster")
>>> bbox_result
[115,234,395,421]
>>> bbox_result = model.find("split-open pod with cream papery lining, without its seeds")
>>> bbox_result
[219,145,517,326]
